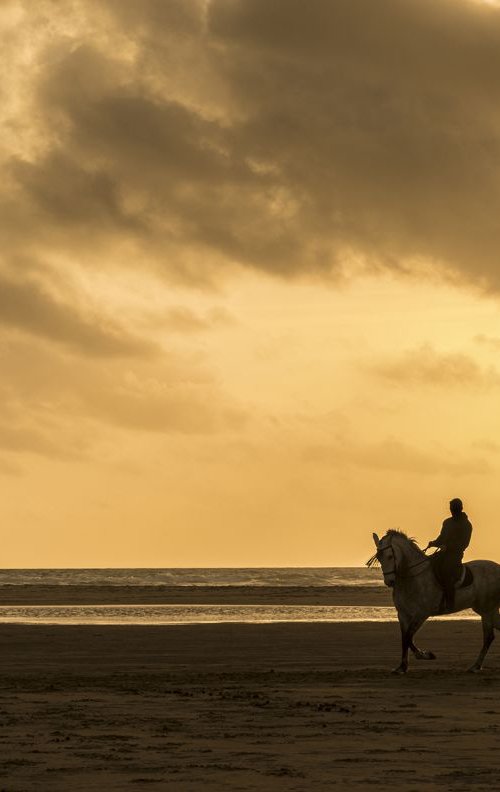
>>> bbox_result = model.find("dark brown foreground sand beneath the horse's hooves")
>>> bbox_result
[0,622,500,792]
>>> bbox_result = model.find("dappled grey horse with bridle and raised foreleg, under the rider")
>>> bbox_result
[366,530,500,674]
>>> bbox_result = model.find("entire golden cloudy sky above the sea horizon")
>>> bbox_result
[0,0,500,567]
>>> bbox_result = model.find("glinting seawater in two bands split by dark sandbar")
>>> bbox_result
[0,567,477,626]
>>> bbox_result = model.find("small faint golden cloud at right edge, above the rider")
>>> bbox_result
[370,345,500,390]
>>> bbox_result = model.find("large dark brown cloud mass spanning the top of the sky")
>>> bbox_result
[2,0,500,289]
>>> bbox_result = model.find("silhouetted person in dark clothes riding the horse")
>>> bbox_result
[428,498,472,611]
